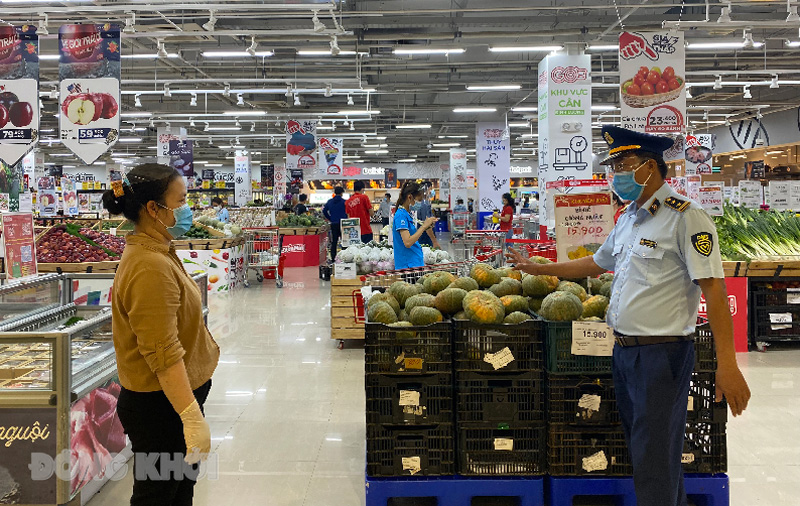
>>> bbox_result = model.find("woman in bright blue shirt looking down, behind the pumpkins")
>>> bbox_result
[392,181,437,269]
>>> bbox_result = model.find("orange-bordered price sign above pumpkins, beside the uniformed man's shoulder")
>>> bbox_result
[553,192,614,262]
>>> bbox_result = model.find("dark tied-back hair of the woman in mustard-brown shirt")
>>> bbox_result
[103,163,181,223]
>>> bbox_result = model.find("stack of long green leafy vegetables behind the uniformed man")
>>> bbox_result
[715,205,800,260]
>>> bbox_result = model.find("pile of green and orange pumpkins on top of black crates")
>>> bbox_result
[367,257,613,327]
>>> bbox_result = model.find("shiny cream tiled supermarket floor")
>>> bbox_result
[90,268,800,506]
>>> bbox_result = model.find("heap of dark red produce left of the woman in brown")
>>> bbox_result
[36,223,125,263]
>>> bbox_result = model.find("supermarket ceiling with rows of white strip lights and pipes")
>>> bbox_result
[6,0,800,163]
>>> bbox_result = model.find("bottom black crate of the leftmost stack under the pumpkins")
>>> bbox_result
[367,424,456,478]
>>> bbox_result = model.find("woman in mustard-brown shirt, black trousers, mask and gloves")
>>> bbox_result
[103,164,220,506]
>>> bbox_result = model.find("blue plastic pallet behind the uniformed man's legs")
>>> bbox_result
[548,474,730,506]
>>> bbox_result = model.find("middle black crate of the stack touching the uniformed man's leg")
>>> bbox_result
[547,375,621,426]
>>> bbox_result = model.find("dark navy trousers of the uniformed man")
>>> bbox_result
[613,341,694,506]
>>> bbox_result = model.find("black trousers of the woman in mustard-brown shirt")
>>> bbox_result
[117,380,211,506]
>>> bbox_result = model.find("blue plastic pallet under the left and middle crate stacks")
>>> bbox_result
[366,476,544,506]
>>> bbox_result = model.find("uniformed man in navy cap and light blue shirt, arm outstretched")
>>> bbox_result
[508,126,750,506]
